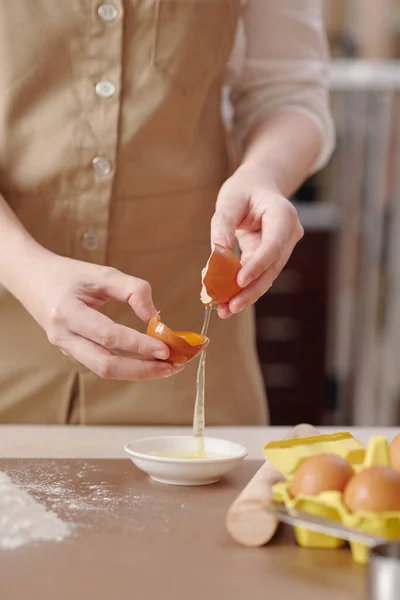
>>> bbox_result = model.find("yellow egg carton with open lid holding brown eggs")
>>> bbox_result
[264,433,400,564]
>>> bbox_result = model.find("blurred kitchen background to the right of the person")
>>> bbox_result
[253,0,400,426]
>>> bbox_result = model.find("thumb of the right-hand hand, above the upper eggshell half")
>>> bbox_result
[211,186,247,249]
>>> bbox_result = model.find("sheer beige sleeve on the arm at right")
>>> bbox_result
[228,0,335,172]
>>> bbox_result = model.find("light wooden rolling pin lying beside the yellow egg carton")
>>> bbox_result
[226,424,318,547]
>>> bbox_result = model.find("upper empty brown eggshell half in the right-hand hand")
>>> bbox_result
[201,244,242,304]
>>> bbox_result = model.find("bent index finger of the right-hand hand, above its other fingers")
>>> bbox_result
[238,211,291,288]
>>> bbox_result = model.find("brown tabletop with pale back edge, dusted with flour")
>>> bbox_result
[0,426,395,600]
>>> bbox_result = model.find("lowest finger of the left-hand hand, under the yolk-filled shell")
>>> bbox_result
[63,335,183,381]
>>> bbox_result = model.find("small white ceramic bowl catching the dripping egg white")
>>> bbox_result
[125,435,247,485]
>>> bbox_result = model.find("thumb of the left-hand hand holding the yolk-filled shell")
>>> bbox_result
[99,268,157,322]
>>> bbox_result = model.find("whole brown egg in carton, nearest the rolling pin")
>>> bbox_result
[289,454,354,498]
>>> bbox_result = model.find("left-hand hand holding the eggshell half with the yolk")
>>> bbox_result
[10,246,182,380]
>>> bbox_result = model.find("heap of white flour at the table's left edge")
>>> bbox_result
[0,471,71,549]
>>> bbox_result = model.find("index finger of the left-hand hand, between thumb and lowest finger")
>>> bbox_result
[66,300,170,360]
